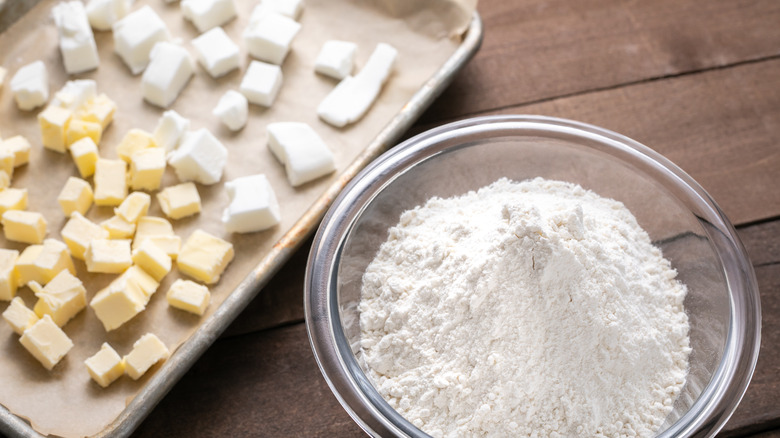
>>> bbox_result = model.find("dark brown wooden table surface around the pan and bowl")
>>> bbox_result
[131,0,780,437]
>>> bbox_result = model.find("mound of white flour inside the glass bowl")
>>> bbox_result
[359,179,690,437]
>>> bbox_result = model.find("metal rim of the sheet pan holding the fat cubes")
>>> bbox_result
[0,0,483,437]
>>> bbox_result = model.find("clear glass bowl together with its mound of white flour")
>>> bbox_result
[304,116,760,437]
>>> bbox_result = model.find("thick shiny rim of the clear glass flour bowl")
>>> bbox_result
[304,115,761,437]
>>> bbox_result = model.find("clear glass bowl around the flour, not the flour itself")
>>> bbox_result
[304,116,761,437]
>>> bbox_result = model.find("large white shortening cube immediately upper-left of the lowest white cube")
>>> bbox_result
[168,128,227,185]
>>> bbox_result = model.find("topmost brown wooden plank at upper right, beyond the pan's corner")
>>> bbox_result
[423,0,780,122]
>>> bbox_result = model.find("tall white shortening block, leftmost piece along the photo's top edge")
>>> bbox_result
[52,1,100,74]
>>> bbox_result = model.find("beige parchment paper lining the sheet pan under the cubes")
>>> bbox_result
[0,0,476,436]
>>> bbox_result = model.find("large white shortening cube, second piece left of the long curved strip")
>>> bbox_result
[244,12,301,65]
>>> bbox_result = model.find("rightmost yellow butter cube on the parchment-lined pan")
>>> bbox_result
[176,230,233,284]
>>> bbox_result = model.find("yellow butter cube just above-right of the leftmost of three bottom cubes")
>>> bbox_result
[30,269,87,327]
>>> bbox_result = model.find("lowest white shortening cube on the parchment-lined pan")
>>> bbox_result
[222,174,281,233]
